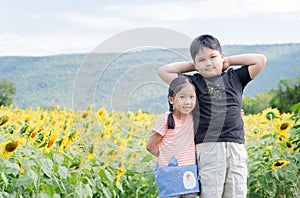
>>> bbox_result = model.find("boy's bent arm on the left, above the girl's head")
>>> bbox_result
[158,62,195,84]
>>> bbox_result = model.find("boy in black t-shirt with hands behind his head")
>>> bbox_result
[158,35,266,198]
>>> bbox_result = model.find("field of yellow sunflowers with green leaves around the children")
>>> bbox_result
[0,104,300,198]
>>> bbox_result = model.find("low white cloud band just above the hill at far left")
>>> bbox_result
[0,33,100,56]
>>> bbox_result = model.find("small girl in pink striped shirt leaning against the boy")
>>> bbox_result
[146,76,199,198]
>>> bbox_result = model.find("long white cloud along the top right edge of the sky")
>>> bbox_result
[106,0,300,21]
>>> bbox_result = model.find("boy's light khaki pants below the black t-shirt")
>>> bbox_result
[196,142,248,198]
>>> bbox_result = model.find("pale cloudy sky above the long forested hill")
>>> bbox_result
[0,0,300,56]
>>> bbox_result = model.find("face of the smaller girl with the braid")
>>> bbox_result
[169,83,196,117]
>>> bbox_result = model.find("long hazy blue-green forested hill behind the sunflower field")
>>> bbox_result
[0,44,300,112]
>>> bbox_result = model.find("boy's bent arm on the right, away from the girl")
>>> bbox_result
[223,54,267,79]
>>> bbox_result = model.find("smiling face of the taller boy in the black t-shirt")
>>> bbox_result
[195,47,224,78]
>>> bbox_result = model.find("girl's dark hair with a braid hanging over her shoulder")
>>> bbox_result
[168,75,193,129]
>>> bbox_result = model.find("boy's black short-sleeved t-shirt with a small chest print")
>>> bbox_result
[185,66,251,144]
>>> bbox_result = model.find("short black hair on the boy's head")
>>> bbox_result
[190,34,222,61]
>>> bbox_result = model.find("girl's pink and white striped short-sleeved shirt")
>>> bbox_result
[152,112,195,166]
